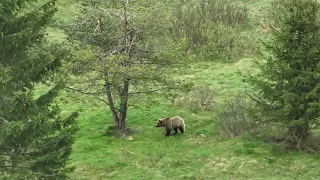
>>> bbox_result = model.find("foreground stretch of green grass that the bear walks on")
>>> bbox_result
[64,97,320,179]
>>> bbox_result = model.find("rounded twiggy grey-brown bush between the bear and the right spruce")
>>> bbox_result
[216,96,258,137]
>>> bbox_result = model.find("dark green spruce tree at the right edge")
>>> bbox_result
[251,0,320,143]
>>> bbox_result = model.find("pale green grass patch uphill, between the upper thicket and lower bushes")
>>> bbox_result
[179,58,253,100]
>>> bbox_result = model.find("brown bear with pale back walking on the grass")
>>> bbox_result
[155,116,185,136]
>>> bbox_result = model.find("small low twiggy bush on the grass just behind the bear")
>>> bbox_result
[174,85,215,113]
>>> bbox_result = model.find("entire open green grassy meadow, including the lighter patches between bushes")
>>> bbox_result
[47,0,320,180]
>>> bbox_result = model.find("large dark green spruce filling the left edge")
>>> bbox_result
[0,0,77,179]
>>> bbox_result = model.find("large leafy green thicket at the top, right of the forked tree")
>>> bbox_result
[170,0,257,59]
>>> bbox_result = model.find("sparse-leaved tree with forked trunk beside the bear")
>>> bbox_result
[63,0,186,131]
